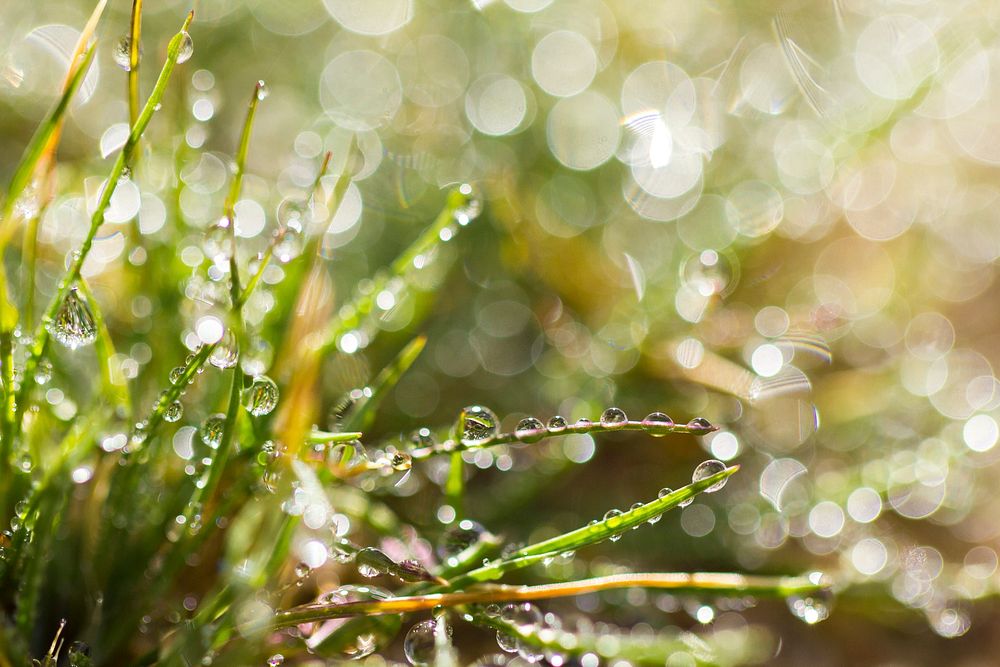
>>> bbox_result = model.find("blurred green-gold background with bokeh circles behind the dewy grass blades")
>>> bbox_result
[0,0,1000,665]
